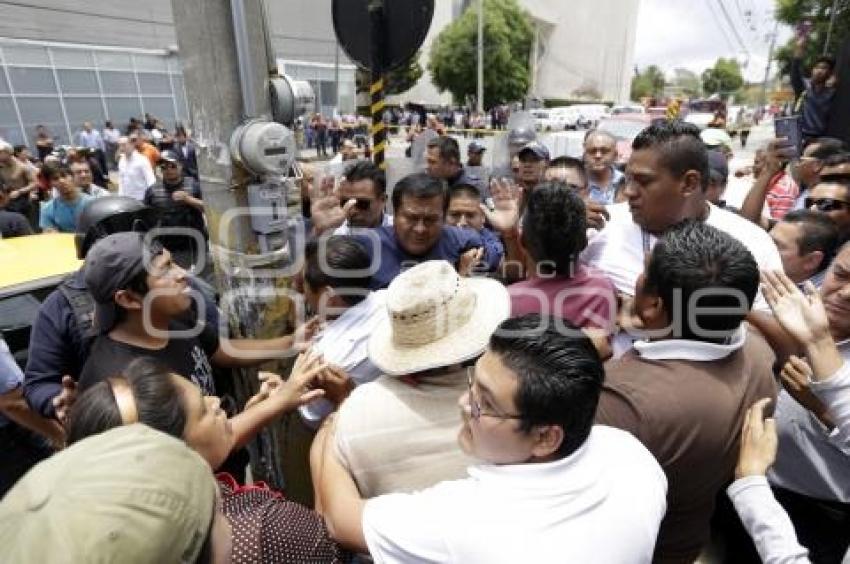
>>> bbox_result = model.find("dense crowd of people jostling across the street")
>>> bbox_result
[0,43,850,563]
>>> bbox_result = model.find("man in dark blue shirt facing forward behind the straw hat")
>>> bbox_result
[361,173,502,289]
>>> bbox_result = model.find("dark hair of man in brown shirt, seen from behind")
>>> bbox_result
[644,220,759,343]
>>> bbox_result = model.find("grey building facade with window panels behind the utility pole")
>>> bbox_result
[0,0,355,144]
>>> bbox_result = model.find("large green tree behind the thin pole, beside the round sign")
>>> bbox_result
[428,0,534,108]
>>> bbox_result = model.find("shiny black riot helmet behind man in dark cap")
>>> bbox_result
[74,196,157,260]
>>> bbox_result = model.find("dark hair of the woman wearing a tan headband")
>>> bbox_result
[68,357,187,445]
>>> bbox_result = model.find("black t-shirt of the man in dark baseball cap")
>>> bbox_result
[79,322,218,395]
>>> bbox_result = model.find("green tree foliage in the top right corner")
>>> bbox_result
[774,0,850,75]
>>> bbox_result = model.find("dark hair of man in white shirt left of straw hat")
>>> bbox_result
[304,235,371,306]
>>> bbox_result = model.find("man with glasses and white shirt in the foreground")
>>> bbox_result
[311,315,667,564]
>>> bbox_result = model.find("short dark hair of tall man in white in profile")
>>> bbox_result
[632,120,708,191]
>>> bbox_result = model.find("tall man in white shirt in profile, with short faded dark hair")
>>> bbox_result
[582,122,782,300]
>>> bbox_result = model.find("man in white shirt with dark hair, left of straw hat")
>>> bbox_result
[299,236,387,427]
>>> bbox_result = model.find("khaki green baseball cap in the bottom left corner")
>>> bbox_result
[0,424,217,564]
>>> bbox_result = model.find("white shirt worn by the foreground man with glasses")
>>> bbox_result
[363,425,667,564]
